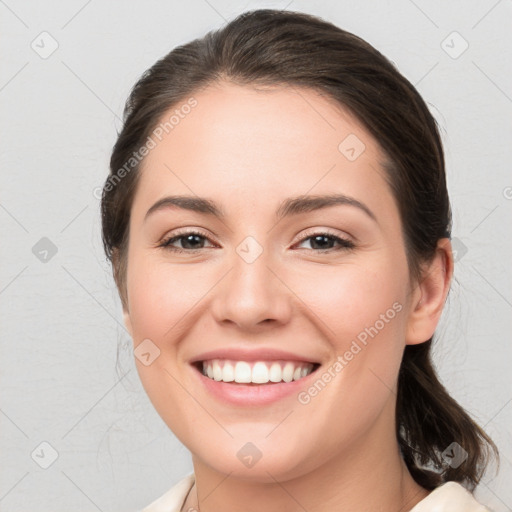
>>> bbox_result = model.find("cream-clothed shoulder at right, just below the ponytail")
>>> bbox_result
[410,482,489,512]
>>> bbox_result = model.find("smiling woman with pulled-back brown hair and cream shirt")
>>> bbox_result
[102,10,496,512]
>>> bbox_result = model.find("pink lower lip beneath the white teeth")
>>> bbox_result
[193,368,317,406]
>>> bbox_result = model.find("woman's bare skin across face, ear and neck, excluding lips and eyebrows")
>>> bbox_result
[120,82,453,512]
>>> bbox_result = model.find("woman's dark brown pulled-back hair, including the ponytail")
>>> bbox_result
[101,9,498,489]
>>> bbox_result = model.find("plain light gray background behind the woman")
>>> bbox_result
[0,0,512,512]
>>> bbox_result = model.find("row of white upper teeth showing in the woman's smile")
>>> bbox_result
[203,359,313,384]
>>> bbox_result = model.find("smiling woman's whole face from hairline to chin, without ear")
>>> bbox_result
[125,83,420,481]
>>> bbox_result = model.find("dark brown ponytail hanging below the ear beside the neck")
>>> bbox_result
[396,339,499,490]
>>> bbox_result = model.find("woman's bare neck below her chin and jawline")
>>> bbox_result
[182,404,428,512]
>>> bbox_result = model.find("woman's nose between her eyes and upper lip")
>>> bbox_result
[212,245,293,332]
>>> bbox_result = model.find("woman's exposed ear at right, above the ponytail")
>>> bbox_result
[405,238,453,345]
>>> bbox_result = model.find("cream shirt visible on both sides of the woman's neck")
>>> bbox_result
[142,473,489,512]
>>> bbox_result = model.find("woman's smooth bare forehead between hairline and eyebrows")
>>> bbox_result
[134,83,392,221]
